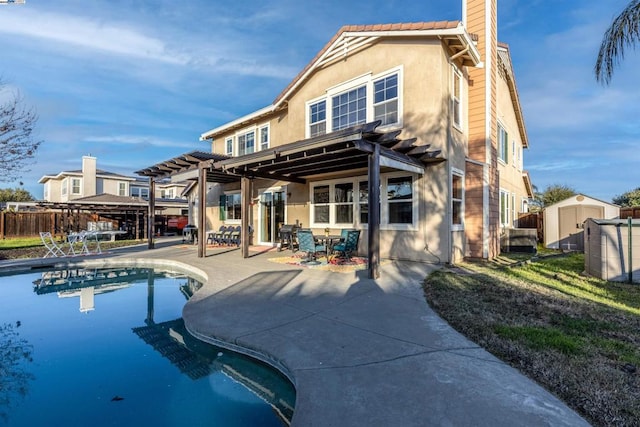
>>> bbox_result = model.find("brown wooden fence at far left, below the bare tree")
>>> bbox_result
[0,211,96,239]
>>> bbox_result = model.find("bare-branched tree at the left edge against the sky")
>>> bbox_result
[0,80,42,182]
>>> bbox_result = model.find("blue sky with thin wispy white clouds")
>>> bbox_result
[0,0,640,201]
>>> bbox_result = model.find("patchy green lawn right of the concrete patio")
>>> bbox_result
[424,254,640,426]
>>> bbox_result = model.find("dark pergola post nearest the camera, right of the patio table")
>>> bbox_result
[367,144,380,279]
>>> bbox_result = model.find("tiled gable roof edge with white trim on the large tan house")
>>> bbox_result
[200,21,481,140]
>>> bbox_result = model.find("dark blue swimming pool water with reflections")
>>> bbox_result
[0,269,295,427]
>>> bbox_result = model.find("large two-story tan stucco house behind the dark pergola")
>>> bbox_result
[194,0,532,262]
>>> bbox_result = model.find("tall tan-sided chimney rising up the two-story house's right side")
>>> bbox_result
[462,0,500,259]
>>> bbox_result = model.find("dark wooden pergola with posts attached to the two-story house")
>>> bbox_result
[136,121,444,278]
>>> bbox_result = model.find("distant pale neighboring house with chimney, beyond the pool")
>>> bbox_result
[38,156,188,215]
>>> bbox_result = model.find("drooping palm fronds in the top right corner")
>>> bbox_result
[595,0,640,84]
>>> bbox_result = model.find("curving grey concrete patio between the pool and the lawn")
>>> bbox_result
[0,241,588,426]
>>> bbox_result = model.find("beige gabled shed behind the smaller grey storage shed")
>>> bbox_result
[542,194,620,251]
